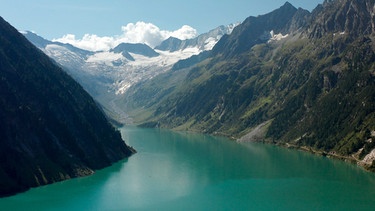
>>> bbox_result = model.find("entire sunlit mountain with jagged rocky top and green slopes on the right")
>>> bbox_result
[123,0,375,171]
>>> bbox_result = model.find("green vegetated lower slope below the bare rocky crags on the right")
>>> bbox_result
[125,34,375,169]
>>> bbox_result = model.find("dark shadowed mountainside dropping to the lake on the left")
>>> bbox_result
[0,18,134,196]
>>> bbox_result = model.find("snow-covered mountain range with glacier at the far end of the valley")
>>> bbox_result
[23,25,235,120]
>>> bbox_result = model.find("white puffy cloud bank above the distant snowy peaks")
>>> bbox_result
[53,21,197,51]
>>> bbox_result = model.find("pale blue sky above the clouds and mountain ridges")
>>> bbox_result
[0,0,323,50]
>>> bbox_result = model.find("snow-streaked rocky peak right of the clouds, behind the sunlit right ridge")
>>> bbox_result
[155,24,237,52]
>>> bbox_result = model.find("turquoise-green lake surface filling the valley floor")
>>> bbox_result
[0,127,375,210]
